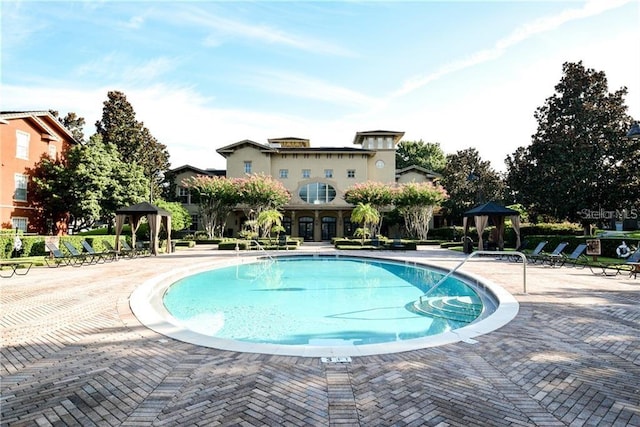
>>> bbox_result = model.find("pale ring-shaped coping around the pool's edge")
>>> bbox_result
[129,252,519,357]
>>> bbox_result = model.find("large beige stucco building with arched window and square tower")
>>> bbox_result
[172,130,437,241]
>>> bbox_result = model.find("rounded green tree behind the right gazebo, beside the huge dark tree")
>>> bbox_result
[441,148,505,222]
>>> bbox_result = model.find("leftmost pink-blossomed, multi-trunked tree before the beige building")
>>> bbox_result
[182,176,240,239]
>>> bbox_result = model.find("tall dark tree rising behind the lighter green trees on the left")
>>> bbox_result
[96,91,169,181]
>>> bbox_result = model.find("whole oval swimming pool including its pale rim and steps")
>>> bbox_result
[131,255,517,356]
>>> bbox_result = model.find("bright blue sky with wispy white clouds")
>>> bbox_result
[0,0,640,171]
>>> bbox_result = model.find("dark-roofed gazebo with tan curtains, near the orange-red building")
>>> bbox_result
[116,202,171,255]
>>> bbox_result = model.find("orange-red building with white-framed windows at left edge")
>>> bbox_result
[0,111,77,234]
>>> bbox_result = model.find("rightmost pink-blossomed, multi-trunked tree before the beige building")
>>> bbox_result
[395,182,447,240]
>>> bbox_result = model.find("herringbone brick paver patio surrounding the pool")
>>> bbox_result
[0,245,640,426]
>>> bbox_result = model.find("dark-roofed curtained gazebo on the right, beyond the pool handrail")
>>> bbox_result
[463,202,520,250]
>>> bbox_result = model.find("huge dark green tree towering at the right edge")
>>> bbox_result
[506,62,640,225]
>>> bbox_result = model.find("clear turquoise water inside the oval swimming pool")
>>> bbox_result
[164,257,482,346]
